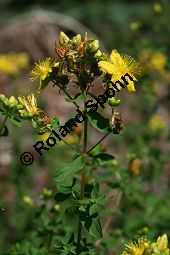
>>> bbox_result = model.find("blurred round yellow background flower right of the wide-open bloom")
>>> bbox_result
[150,52,167,71]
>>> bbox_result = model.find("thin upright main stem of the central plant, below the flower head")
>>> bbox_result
[77,108,88,254]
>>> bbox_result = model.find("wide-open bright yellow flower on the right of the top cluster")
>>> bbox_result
[98,50,139,92]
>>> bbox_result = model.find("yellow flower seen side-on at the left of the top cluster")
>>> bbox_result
[30,58,59,91]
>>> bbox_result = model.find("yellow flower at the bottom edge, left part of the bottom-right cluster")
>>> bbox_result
[122,237,149,255]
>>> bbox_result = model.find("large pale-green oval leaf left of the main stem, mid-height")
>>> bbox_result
[55,155,86,182]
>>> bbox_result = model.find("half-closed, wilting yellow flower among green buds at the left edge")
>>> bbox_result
[18,93,38,115]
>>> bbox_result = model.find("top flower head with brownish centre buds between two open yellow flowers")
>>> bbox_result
[31,32,139,92]
